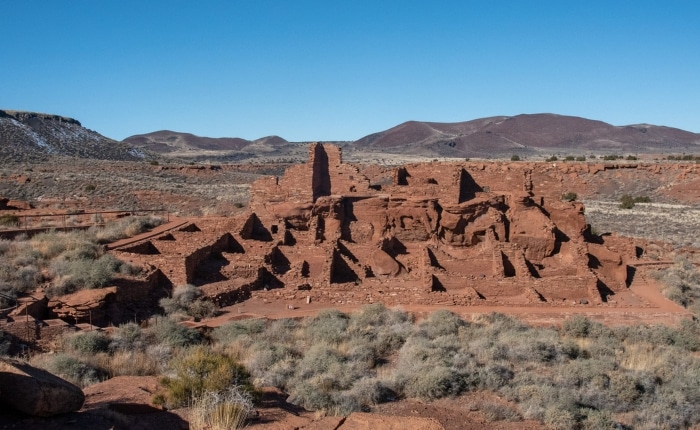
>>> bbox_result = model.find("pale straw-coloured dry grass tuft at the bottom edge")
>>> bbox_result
[189,386,253,430]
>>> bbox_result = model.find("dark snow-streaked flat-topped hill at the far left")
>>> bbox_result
[0,110,144,161]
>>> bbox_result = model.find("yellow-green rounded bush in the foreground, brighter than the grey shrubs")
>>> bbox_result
[157,346,252,408]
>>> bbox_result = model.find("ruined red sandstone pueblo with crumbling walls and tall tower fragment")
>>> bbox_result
[114,143,635,306]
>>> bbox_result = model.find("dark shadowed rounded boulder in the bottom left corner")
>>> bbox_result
[0,358,85,417]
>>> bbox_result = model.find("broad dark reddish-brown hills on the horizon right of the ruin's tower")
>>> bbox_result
[353,114,700,157]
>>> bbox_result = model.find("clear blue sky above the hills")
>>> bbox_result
[0,0,700,141]
